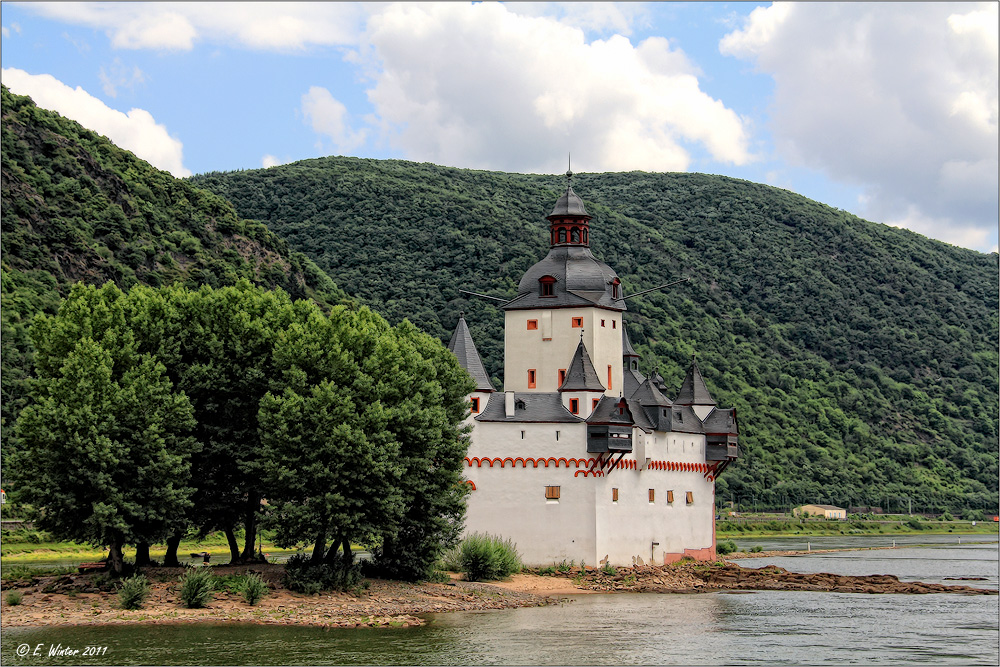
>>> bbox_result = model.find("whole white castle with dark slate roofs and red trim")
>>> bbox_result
[448,173,738,566]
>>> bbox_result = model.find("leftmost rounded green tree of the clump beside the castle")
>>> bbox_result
[8,334,195,574]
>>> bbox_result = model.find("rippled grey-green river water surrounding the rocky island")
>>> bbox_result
[0,536,1000,666]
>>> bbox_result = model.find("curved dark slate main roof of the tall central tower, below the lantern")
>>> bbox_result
[503,246,627,311]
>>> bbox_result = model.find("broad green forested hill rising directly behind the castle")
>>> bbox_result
[192,158,998,512]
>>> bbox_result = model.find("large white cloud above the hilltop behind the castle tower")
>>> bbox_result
[361,3,751,172]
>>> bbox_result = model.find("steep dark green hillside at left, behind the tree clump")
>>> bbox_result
[0,88,346,454]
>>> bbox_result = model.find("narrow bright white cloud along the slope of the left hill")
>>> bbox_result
[2,68,191,177]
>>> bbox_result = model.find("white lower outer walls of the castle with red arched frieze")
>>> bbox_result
[466,422,715,566]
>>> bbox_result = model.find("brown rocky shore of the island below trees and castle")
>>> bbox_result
[0,561,997,628]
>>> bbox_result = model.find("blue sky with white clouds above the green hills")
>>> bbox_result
[0,2,1000,252]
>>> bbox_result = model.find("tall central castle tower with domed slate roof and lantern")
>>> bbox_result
[503,172,626,396]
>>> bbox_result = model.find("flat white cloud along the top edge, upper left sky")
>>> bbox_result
[23,2,377,51]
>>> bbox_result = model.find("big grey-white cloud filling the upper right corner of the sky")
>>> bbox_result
[719,3,998,250]
